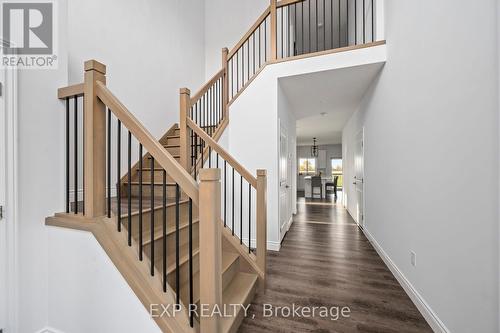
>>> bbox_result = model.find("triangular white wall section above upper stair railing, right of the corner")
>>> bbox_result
[205,0,270,79]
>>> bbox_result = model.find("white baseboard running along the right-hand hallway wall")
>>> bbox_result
[362,228,450,333]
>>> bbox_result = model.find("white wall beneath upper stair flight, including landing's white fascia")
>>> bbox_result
[226,45,386,250]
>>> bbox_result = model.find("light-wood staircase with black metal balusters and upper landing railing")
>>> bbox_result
[46,0,383,333]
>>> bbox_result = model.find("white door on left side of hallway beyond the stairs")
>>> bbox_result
[279,125,289,238]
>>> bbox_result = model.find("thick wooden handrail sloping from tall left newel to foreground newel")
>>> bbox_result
[96,82,199,206]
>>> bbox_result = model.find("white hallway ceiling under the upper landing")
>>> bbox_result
[279,63,383,145]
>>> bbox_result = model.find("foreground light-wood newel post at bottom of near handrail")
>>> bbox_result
[199,169,222,333]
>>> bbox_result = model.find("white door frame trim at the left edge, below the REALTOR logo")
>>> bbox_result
[0,60,18,333]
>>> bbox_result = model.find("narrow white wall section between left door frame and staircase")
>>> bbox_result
[14,1,67,333]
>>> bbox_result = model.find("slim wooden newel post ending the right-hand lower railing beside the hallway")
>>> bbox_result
[256,170,267,291]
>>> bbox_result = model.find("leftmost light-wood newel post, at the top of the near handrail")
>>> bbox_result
[83,60,106,218]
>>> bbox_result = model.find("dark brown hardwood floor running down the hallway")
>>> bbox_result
[239,195,432,333]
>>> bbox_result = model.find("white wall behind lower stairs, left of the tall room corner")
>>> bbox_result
[68,0,205,137]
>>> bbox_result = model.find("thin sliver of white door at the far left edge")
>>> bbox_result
[0,69,7,332]
